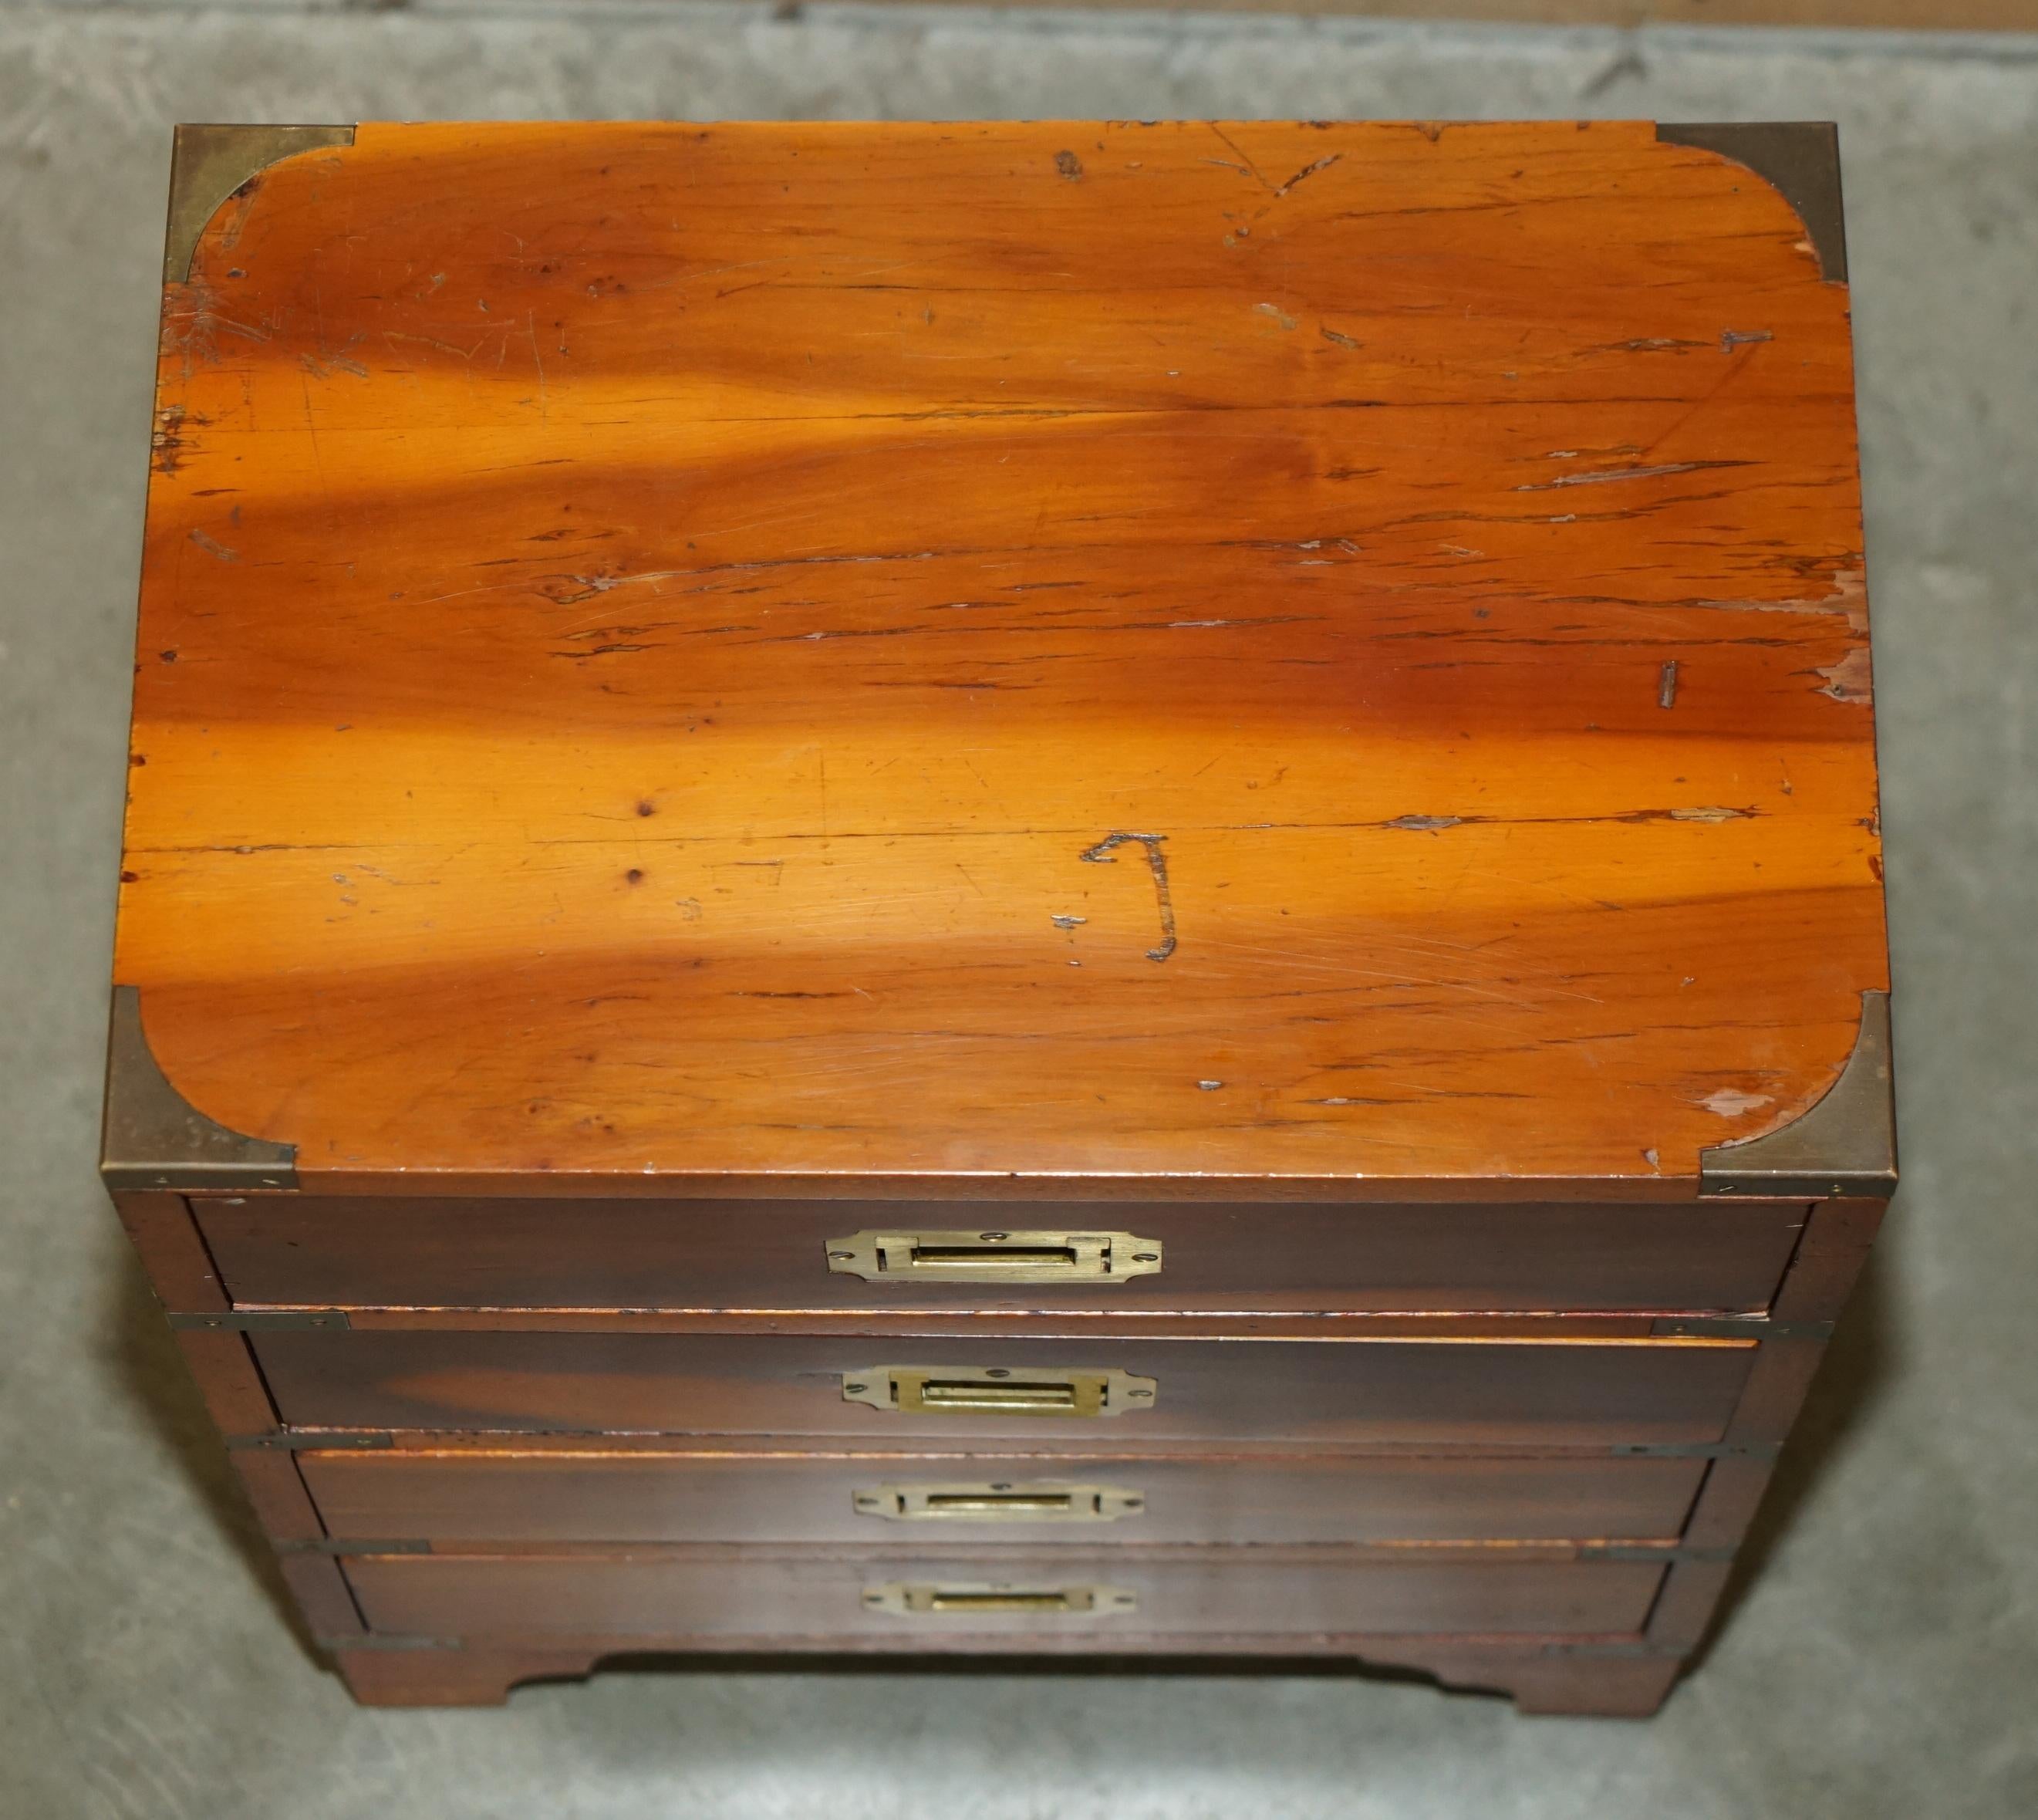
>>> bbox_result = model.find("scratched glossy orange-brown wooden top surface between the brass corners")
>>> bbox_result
[116,122,1887,1194]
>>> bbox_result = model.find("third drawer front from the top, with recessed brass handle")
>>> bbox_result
[298,1447,1706,1547]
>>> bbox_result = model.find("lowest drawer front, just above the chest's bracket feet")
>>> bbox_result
[344,1549,1663,1651]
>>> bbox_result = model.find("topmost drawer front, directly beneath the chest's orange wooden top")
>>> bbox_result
[194,1197,1806,1315]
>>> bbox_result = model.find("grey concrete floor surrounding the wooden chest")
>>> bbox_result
[0,0,2038,1820]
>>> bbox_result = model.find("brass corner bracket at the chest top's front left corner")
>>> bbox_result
[100,987,298,1194]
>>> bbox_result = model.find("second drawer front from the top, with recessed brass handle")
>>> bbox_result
[251,1329,1755,1451]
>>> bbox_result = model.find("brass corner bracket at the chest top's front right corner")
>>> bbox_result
[1698,992,1898,1200]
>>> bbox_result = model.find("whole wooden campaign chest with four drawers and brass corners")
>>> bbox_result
[104,122,1895,1714]
